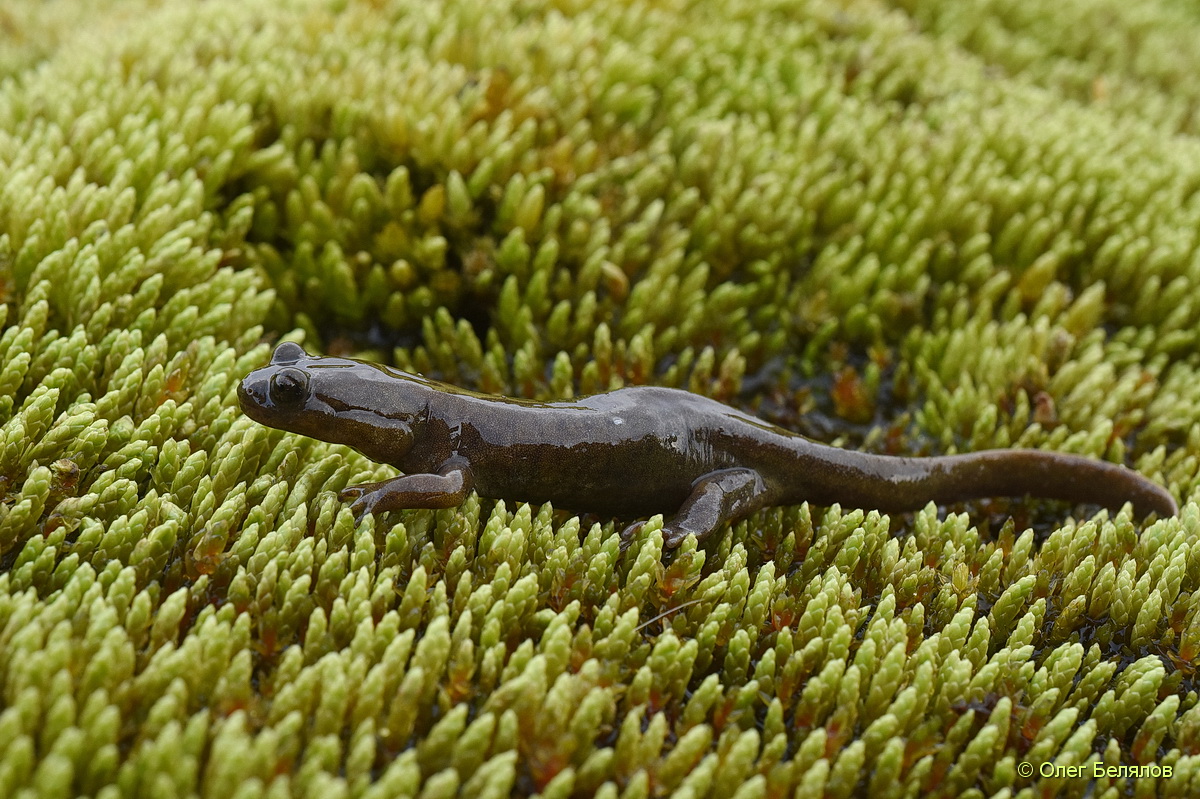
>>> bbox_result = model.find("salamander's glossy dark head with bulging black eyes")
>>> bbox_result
[238,342,427,463]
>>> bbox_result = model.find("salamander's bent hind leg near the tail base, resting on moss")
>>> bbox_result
[620,469,769,549]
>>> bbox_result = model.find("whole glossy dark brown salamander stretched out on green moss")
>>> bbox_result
[238,343,1178,547]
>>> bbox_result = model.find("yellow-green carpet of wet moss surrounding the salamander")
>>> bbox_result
[0,0,1200,799]
